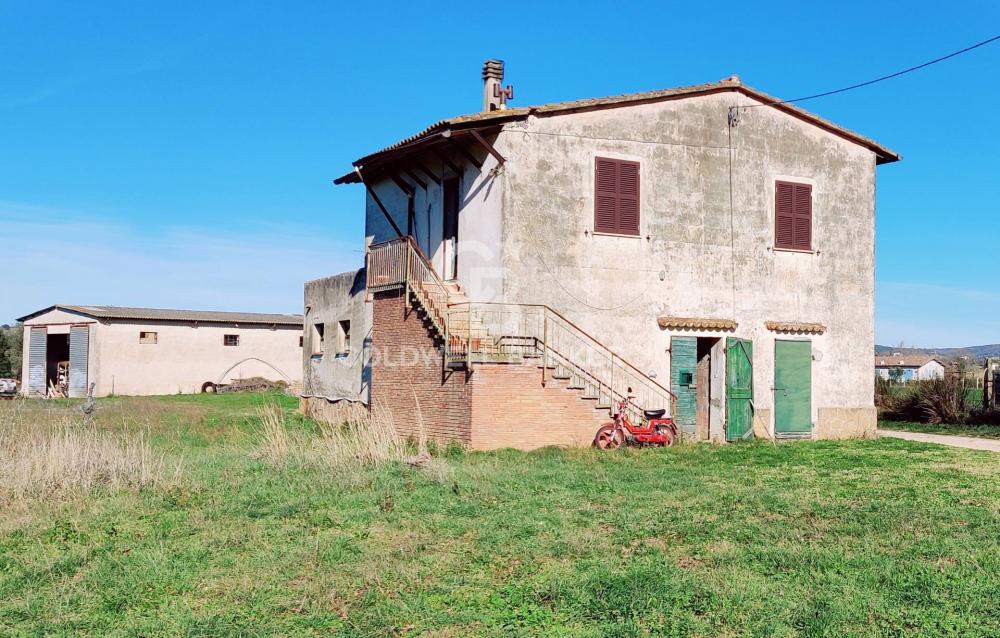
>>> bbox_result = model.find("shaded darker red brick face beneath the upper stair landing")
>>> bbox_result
[371,290,472,444]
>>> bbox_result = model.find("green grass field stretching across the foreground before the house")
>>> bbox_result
[0,395,1000,638]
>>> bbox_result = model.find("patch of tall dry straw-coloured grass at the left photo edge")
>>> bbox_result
[0,401,173,502]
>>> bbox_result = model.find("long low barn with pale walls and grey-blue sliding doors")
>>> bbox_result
[18,305,302,397]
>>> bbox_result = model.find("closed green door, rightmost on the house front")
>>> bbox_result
[774,340,812,436]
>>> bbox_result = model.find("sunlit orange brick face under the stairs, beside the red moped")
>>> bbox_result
[470,363,611,450]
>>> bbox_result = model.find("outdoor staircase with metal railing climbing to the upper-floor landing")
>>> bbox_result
[368,239,674,428]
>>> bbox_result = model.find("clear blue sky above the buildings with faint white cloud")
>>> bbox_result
[0,1,1000,346]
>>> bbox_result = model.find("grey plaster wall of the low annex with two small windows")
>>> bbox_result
[301,269,372,403]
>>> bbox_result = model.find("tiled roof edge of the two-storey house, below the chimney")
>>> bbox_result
[336,77,900,184]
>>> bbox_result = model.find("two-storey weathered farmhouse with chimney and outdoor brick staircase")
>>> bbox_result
[305,60,899,449]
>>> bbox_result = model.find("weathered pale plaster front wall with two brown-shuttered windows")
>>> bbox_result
[499,93,875,434]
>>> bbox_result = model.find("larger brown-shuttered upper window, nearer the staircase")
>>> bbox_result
[594,157,639,235]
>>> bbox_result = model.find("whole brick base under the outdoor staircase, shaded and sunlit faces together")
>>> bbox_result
[371,291,610,450]
